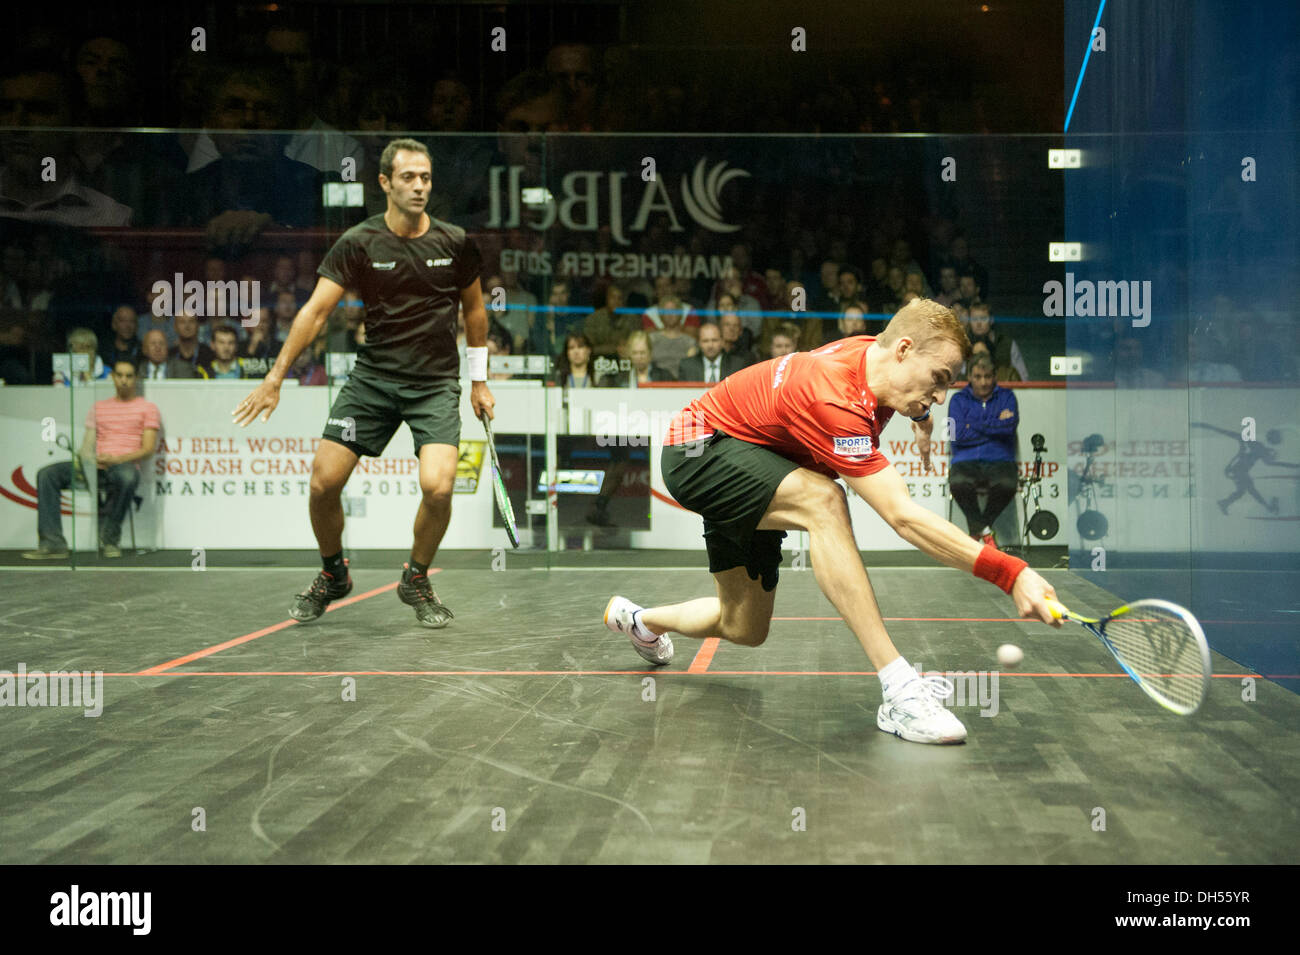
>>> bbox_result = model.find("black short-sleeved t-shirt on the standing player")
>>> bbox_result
[316,214,482,382]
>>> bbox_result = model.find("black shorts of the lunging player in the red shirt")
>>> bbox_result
[660,431,800,590]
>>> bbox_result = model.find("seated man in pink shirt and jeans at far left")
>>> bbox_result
[22,359,163,560]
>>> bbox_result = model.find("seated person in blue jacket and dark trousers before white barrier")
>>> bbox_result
[948,355,1021,544]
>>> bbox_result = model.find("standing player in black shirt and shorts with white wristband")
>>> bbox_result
[233,139,495,629]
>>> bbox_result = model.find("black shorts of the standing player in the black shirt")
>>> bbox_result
[321,374,460,457]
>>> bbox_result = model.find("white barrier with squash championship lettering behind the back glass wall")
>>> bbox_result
[0,381,1076,551]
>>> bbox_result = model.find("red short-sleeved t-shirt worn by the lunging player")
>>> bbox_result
[664,335,893,477]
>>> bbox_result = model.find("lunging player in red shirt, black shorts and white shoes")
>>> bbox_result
[605,299,1060,743]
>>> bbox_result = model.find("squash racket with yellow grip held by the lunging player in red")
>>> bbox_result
[1048,600,1210,716]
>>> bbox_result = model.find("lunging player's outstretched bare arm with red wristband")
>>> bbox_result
[841,468,1061,626]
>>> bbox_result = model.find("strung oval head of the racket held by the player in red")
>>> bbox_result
[1104,607,1204,708]
